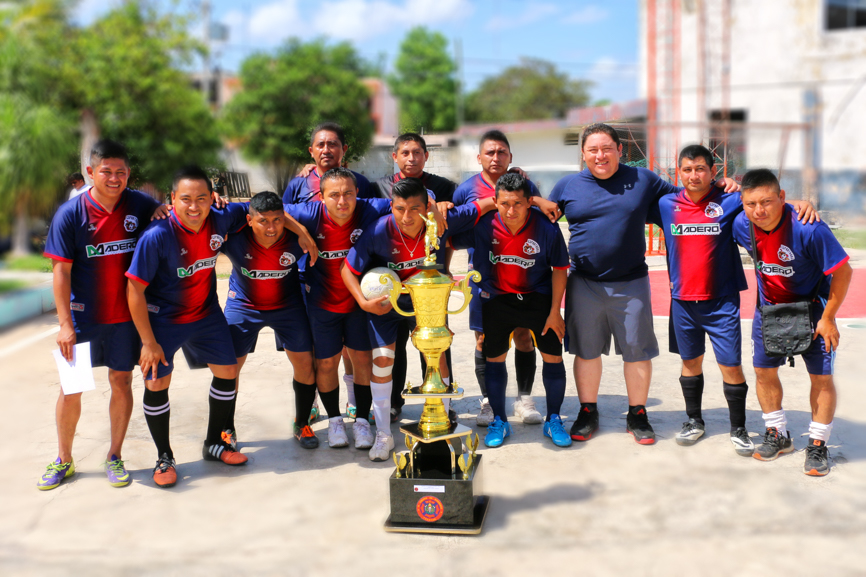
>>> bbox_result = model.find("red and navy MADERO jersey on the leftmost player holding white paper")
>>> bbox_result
[44,189,160,326]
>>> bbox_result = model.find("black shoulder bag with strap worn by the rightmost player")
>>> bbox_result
[749,222,824,367]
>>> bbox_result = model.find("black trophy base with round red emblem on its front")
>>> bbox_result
[385,441,490,535]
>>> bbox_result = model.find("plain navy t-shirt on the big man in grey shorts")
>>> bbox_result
[552,164,678,281]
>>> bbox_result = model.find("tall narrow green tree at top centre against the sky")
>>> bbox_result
[388,26,457,132]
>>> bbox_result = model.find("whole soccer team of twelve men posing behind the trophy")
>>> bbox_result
[37,123,852,490]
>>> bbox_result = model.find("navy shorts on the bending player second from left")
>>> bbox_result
[145,311,237,380]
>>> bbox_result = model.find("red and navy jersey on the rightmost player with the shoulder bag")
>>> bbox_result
[734,204,848,304]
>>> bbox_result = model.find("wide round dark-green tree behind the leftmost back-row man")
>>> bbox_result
[222,39,373,192]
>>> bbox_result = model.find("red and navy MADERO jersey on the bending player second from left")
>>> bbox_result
[126,203,249,324]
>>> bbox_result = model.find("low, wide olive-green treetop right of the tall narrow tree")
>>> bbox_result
[466,58,592,122]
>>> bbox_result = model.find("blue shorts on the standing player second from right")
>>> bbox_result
[668,293,743,367]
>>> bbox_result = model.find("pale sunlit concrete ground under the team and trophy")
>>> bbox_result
[0,264,866,577]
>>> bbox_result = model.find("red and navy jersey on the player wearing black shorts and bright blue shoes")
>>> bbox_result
[451,210,569,297]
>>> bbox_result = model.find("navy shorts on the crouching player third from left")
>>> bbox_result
[225,300,313,357]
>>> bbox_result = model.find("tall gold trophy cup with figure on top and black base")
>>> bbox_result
[380,213,490,534]
